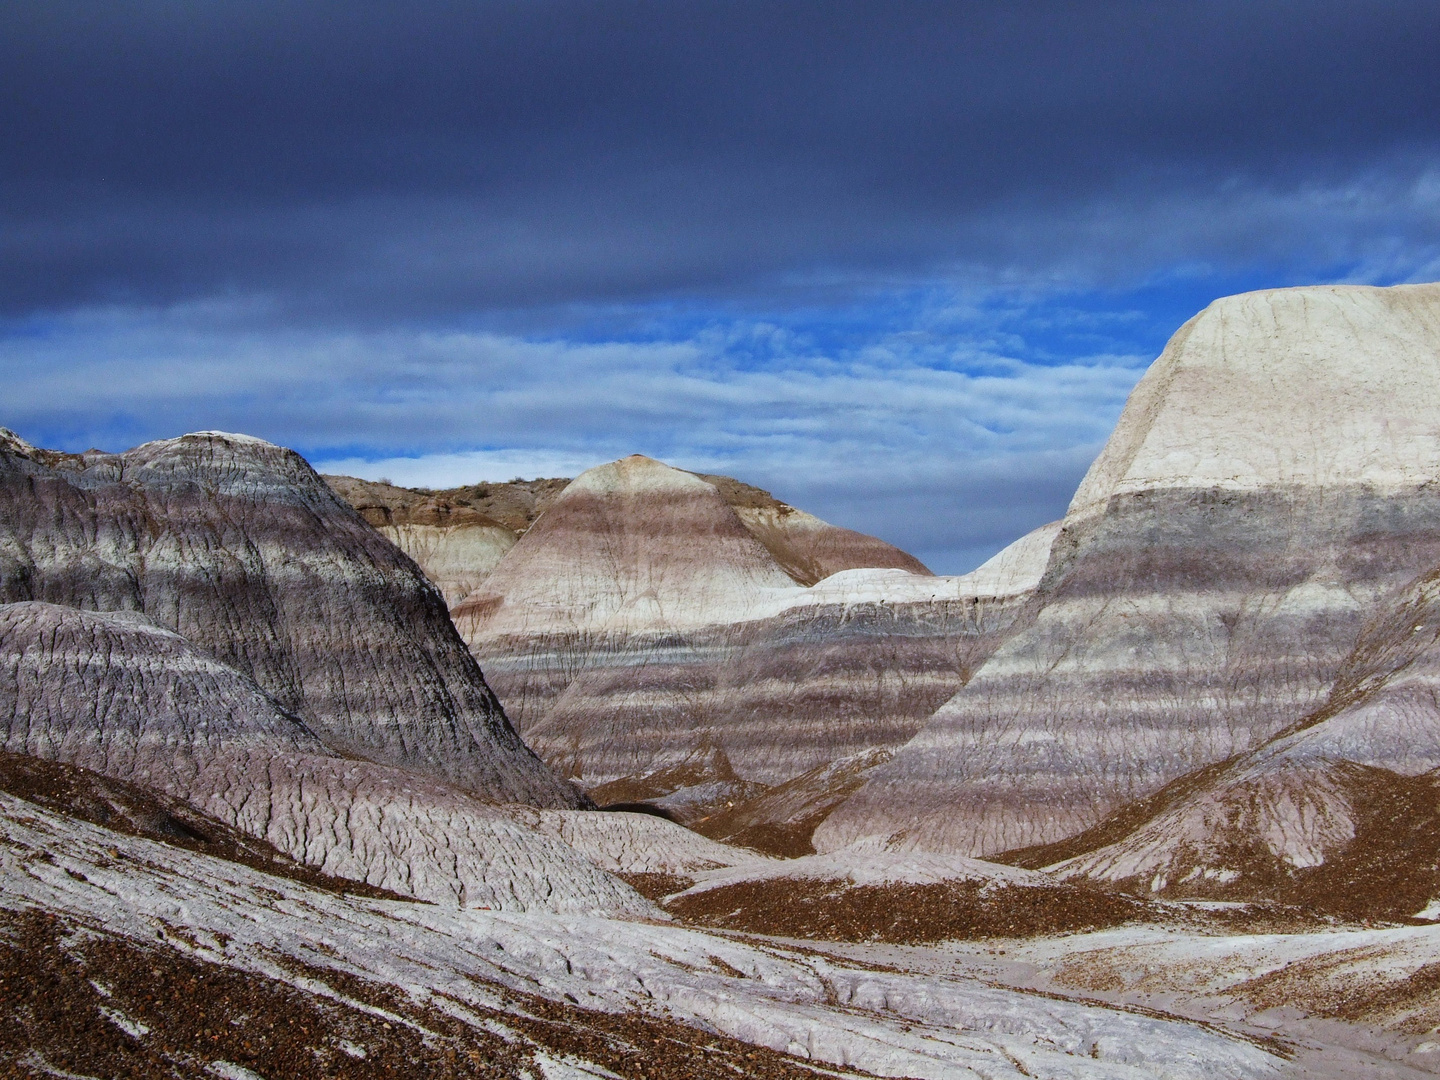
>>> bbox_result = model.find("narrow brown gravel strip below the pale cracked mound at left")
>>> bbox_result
[0,750,425,904]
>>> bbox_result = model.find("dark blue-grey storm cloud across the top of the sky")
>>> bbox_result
[8,0,1440,317]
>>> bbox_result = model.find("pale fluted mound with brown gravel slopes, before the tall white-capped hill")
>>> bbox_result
[1021,558,1440,917]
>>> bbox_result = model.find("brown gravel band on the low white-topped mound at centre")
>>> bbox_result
[665,878,1149,945]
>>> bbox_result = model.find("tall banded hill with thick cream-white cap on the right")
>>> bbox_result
[815,285,1440,854]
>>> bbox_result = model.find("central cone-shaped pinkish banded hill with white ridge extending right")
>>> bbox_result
[454,456,1050,844]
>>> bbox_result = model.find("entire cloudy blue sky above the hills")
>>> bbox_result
[0,0,1440,573]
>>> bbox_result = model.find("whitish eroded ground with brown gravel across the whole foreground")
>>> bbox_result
[0,795,1440,1080]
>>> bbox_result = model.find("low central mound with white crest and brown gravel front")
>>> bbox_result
[664,842,1148,945]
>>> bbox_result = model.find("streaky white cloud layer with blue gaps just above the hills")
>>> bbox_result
[0,297,1149,570]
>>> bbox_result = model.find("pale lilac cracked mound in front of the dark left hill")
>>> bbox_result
[0,602,648,914]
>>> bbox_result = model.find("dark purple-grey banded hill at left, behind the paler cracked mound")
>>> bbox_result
[0,432,577,806]
